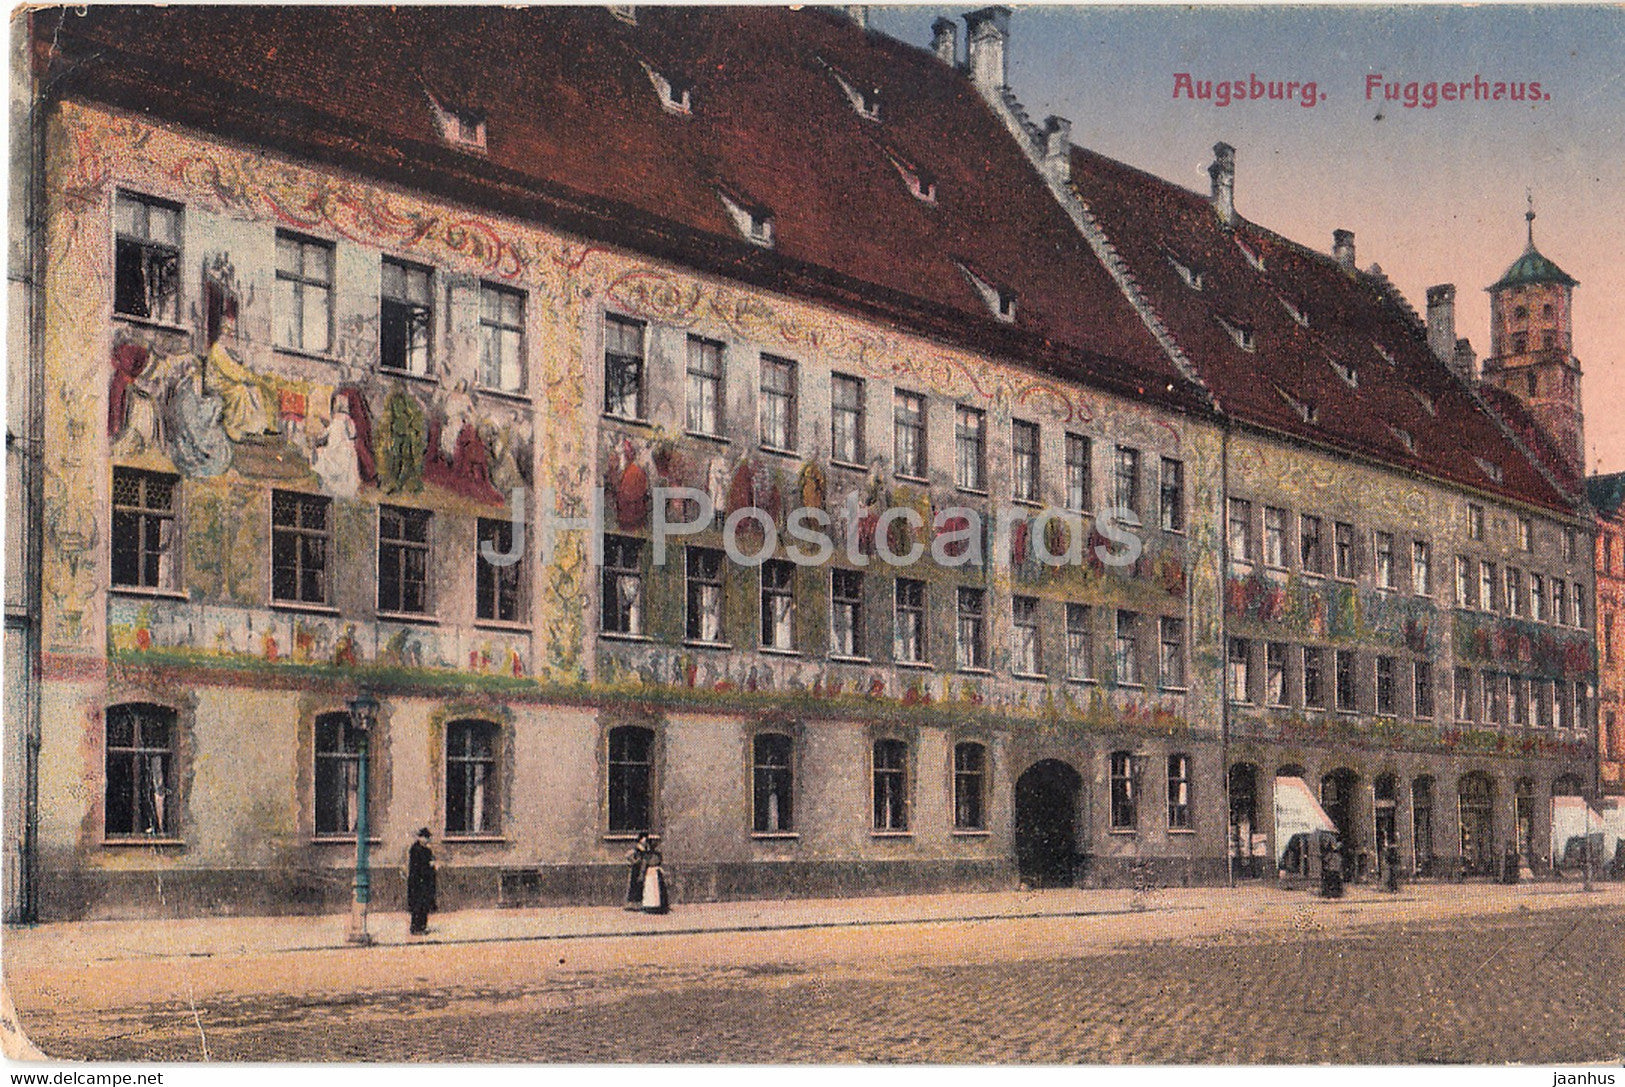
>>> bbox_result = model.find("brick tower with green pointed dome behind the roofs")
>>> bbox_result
[1484,200,1586,473]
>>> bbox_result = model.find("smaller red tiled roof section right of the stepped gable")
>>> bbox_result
[1073,148,1573,510]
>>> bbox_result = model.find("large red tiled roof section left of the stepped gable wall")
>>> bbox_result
[36,5,1204,408]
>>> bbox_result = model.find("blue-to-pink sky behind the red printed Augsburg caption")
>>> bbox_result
[871,5,1625,471]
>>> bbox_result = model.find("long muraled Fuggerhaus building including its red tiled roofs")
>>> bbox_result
[8,10,1596,918]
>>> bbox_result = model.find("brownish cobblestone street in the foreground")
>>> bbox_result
[13,895,1625,1063]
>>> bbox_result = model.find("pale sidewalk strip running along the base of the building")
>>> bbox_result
[3,882,1625,972]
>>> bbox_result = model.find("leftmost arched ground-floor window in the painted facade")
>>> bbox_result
[102,704,176,838]
